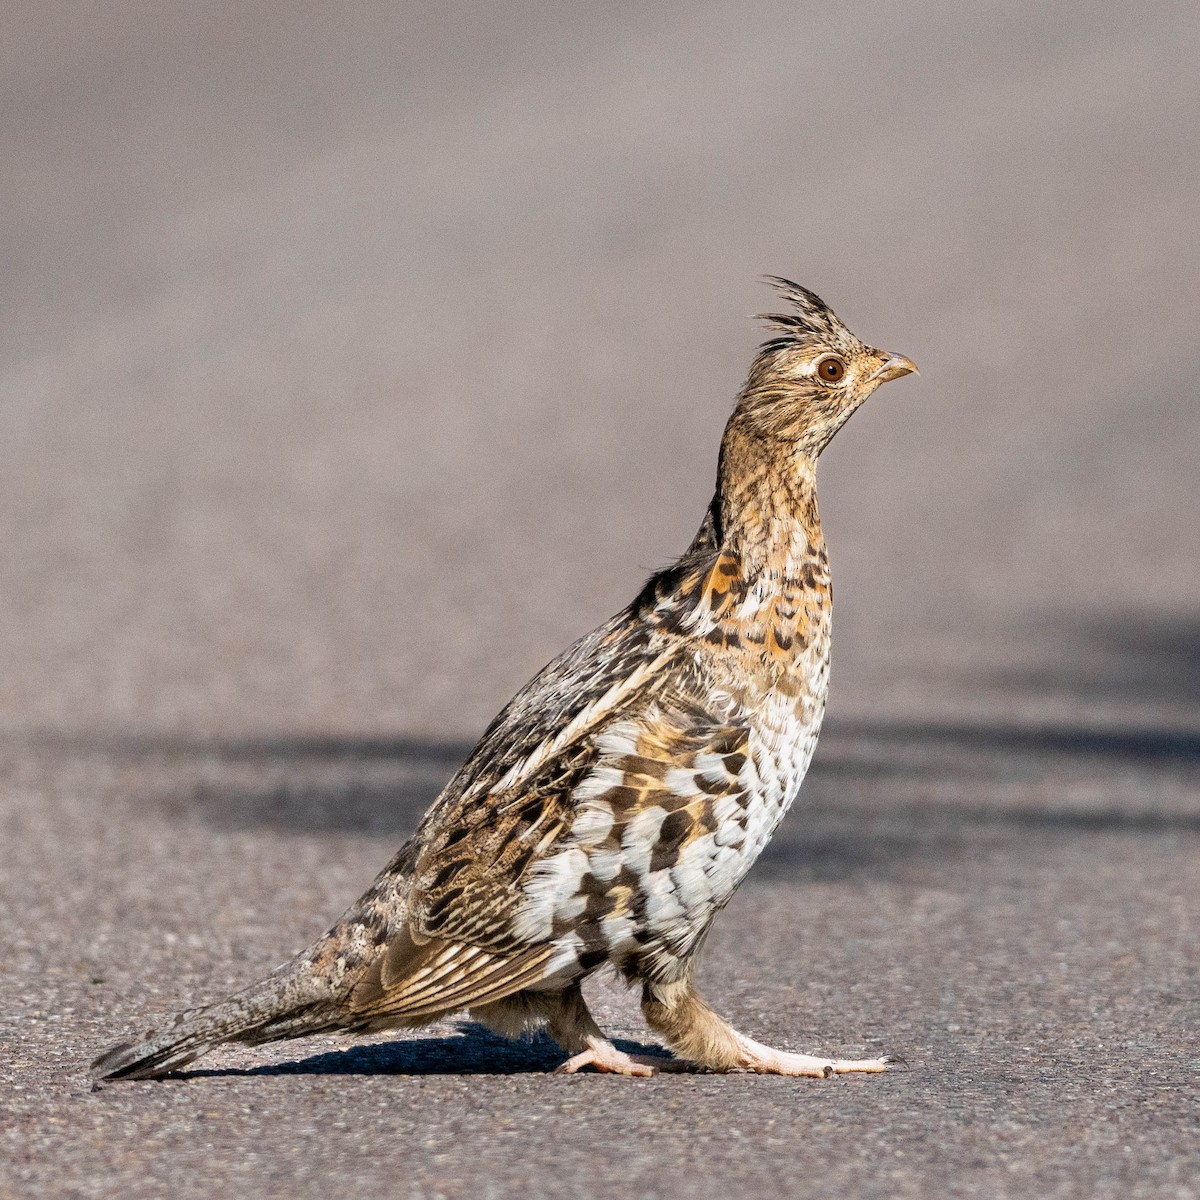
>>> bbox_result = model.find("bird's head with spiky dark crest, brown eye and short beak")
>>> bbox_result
[734,275,917,458]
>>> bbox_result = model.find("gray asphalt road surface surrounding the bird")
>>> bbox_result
[0,0,1200,1200]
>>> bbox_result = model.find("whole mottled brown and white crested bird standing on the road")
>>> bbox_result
[92,278,916,1079]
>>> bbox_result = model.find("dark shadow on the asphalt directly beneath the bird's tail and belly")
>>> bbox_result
[172,1022,671,1079]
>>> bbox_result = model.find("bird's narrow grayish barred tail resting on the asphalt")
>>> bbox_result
[91,955,337,1080]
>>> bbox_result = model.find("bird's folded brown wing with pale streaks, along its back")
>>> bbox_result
[340,611,696,1020]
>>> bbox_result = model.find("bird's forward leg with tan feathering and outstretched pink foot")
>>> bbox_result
[642,977,888,1079]
